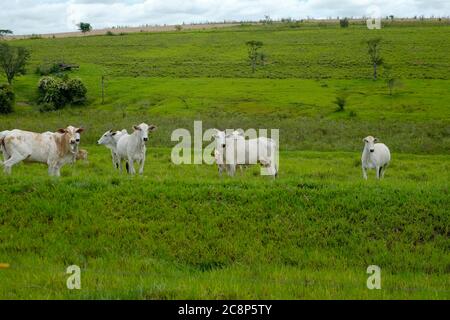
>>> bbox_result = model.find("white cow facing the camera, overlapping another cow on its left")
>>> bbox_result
[117,123,157,174]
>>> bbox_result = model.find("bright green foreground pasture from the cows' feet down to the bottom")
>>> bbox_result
[0,147,450,299]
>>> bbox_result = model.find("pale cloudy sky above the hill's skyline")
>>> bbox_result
[0,0,450,34]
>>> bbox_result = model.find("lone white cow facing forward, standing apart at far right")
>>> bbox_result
[361,136,391,180]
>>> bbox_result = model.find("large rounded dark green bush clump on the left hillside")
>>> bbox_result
[38,75,87,111]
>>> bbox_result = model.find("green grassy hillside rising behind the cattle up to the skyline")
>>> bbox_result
[4,25,450,153]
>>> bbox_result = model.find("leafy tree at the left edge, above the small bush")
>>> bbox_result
[0,43,30,85]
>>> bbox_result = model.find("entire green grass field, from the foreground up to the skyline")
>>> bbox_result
[0,24,450,299]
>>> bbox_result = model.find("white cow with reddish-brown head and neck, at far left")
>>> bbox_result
[0,126,83,176]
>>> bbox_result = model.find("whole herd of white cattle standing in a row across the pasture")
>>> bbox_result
[0,123,391,179]
